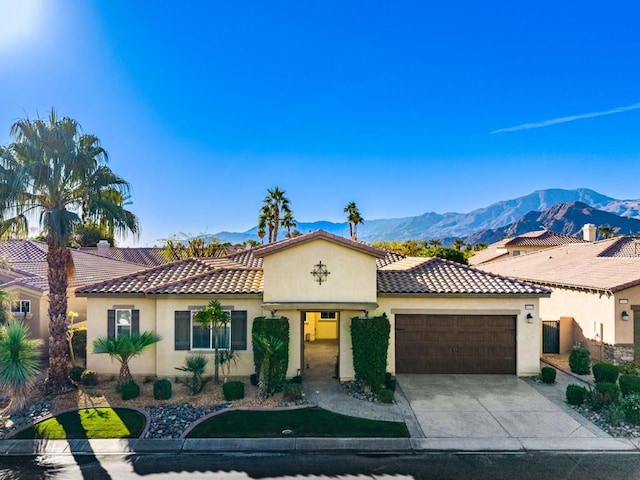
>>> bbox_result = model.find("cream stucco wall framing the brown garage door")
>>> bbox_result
[378,297,541,376]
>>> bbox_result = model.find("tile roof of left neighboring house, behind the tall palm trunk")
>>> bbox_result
[0,240,144,291]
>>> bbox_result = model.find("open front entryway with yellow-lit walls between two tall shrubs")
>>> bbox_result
[300,312,340,381]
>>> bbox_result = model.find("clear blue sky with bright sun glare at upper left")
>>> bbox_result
[0,0,640,245]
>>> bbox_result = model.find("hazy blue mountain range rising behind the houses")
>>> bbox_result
[212,188,640,243]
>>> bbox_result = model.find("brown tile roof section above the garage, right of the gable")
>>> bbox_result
[378,257,550,296]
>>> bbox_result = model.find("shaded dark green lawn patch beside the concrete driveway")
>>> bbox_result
[187,407,409,438]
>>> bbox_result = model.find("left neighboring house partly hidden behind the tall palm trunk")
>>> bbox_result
[0,240,145,355]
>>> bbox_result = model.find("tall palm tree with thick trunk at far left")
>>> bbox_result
[0,109,138,392]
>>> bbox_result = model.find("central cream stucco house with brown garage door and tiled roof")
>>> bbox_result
[76,230,549,379]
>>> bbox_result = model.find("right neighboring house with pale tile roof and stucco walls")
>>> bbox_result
[478,237,640,361]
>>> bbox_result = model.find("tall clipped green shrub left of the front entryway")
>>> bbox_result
[251,317,289,392]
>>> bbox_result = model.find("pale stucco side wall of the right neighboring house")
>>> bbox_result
[540,287,616,344]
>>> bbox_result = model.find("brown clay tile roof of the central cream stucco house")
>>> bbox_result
[76,232,547,296]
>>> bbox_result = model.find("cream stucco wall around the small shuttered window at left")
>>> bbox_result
[87,297,159,375]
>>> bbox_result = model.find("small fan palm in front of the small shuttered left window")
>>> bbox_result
[93,331,160,391]
